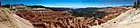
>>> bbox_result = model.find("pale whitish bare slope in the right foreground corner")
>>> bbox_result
[103,9,140,28]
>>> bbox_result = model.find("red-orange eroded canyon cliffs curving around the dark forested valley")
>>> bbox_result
[16,7,129,28]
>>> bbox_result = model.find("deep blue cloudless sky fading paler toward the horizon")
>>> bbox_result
[2,0,135,7]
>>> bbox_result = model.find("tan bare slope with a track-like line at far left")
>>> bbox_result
[0,8,34,28]
